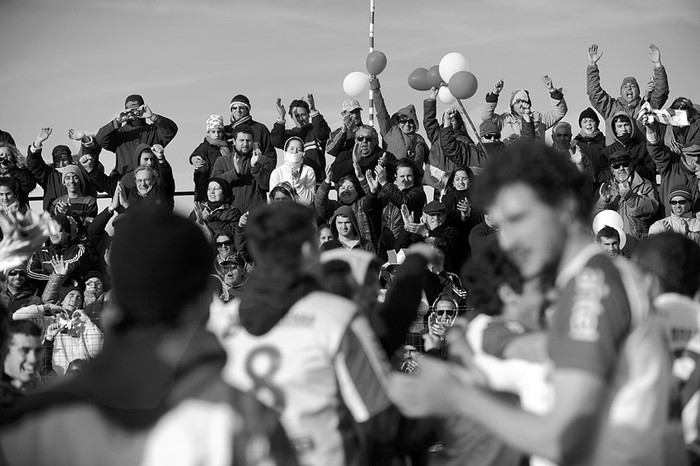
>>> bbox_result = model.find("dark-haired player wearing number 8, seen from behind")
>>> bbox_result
[210,203,396,466]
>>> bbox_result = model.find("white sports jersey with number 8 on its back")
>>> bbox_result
[210,292,390,466]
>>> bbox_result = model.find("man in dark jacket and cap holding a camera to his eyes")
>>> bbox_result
[95,94,178,175]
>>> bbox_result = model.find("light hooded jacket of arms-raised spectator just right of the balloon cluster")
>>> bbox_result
[481,90,568,141]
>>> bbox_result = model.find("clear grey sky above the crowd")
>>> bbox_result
[0,0,700,213]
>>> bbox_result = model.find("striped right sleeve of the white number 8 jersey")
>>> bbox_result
[335,315,391,422]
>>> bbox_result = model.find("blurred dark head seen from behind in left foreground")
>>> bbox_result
[111,206,214,331]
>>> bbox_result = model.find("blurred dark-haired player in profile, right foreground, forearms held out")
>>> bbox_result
[390,145,671,466]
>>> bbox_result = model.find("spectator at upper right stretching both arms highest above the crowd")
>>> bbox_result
[586,44,668,144]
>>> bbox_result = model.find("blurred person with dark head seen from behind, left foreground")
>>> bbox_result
[0,208,297,466]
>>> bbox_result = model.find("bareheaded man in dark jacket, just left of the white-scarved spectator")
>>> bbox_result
[210,126,277,213]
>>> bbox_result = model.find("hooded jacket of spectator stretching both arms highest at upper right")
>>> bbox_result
[586,65,668,144]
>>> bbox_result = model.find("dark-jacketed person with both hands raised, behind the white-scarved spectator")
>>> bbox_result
[270,94,331,183]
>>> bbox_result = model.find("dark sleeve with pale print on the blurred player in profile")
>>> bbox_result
[549,256,631,379]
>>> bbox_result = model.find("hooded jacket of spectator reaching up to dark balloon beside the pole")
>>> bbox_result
[374,89,430,167]
